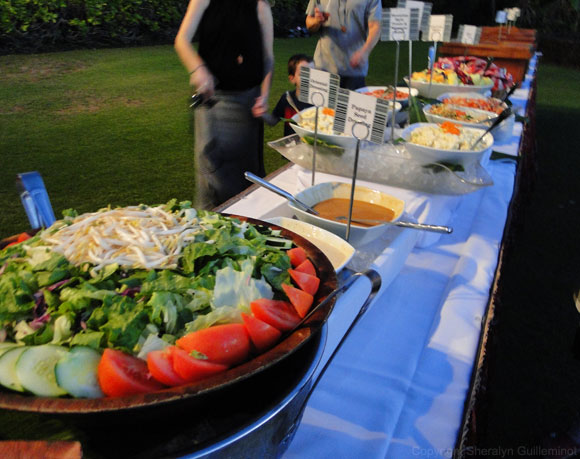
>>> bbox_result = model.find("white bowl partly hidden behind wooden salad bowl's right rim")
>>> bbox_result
[266,217,355,273]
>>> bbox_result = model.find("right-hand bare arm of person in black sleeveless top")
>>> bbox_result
[252,0,274,118]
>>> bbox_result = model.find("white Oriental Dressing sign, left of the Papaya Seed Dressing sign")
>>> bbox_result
[298,67,340,108]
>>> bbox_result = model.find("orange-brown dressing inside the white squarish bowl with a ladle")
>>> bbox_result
[314,198,395,227]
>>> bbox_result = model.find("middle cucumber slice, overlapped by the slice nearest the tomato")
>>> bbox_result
[16,344,68,397]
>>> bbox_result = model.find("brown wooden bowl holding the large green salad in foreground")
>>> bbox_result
[0,215,338,423]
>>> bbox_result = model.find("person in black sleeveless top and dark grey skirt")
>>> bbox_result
[175,0,274,209]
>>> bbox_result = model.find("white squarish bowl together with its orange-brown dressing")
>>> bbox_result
[289,182,405,248]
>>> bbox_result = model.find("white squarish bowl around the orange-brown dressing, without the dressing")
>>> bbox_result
[288,182,405,247]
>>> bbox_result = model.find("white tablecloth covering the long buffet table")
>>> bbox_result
[205,56,537,458]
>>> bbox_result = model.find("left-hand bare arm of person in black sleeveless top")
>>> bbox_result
[174,0,214,98]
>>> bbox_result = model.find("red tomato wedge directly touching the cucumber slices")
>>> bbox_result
[97,349,164,397]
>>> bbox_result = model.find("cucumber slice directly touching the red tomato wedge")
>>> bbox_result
[55,346,105,398]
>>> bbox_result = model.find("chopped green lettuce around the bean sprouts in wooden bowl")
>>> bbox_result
[0,201,292,354]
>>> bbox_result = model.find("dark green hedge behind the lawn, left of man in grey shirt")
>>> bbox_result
[0,0,308,54]
